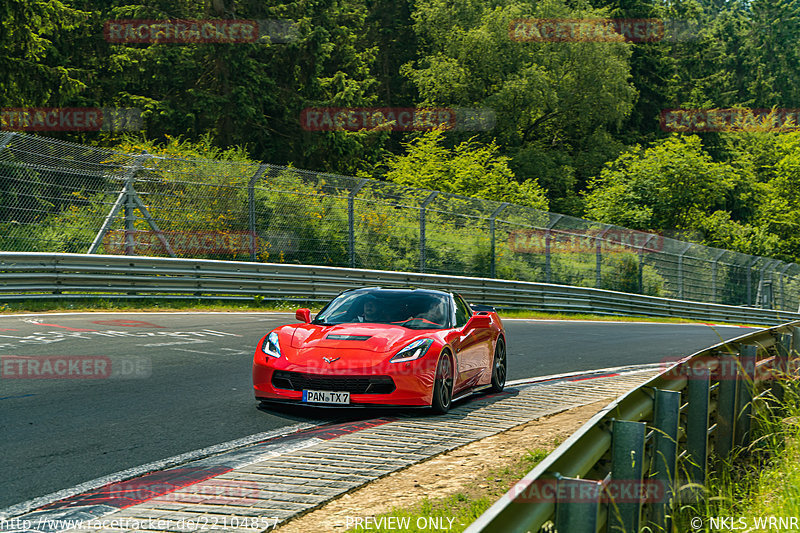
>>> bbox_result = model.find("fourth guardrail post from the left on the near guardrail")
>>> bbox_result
[686,368,710,485]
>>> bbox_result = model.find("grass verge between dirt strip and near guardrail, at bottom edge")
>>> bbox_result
[348,443,557,533]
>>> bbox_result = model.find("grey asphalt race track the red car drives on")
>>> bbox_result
[0,313,760,509]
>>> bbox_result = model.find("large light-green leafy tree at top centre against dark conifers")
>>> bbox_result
[403,0,635,212]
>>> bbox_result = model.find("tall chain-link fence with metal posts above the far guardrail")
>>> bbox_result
[0,132,800,311]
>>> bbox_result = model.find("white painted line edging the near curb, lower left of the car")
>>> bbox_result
[0,422,320,520]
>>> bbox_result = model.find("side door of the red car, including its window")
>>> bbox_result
[454,294,492,392]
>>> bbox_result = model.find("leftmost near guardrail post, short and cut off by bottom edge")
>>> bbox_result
[555,477,602,533]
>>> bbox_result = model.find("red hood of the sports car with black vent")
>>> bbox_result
[291,324,425,353]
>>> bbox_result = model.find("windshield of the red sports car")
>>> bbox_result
[314,290,450,329]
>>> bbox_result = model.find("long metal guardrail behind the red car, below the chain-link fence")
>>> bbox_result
[0,252,800,325]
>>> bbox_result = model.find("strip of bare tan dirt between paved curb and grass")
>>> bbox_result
[276,398,614,533]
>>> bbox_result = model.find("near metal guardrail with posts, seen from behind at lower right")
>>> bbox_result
[466,321,800,533]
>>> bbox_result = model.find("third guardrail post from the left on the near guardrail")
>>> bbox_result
[652,389,681,531]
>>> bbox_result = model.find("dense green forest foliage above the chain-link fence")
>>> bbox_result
[0,0,800,261]
